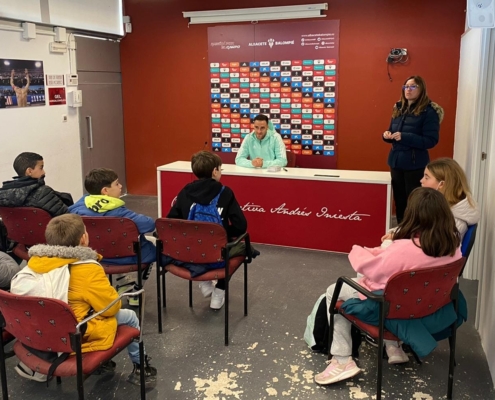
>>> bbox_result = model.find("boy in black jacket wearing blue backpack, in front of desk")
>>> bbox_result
[167,151,247,310]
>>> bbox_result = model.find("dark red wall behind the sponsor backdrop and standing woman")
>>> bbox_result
[121,0,466,195]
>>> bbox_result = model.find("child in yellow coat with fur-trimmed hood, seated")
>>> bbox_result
[11,214,156,385]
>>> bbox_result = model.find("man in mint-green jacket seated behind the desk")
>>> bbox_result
[235,114,287,168]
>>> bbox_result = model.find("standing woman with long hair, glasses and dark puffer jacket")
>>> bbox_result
[382,75,443,223]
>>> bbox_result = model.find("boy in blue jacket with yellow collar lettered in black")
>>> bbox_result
[69,168,156,306]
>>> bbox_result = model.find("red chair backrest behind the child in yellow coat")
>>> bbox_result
[0,290,77,353]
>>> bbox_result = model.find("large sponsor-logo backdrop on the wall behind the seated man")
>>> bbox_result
[208,20,339,168]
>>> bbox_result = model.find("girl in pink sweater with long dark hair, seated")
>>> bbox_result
[315,188,462,385]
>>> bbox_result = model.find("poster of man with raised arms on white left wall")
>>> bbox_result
[0,58,45,108]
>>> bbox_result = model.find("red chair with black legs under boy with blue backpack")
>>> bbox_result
[156,218,252,346]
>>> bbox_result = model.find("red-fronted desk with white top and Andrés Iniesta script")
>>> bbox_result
[157,161,392,253]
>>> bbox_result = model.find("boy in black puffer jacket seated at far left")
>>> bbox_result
[0,153,74,216]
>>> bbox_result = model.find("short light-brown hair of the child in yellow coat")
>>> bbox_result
[45,214,86,247]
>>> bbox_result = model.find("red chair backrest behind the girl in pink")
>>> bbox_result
[384,257,466,319]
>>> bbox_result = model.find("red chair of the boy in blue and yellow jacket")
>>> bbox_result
[82,216,149,287]
